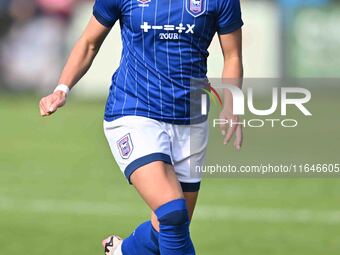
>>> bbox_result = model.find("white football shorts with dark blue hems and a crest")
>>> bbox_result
[104,116,208,192]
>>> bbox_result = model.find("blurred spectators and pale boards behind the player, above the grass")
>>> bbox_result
[0,0,340,94]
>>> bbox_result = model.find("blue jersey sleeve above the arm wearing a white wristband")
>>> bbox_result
[93,0,121,28]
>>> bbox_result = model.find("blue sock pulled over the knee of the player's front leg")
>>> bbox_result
[155,199,195,255]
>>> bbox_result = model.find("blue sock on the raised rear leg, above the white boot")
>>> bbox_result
[122,221,160,255]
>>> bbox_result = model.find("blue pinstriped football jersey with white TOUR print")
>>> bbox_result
[93,0,243,124]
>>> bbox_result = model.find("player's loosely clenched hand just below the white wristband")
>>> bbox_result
[39,91,67,117]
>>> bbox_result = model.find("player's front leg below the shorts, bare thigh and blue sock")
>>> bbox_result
[127,161,195,255]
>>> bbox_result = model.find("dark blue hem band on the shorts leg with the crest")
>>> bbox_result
[124,153,172,184]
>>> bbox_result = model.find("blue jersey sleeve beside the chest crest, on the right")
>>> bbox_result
[217,0,243,35]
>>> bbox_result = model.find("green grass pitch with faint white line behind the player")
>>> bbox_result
[0,96,340,255]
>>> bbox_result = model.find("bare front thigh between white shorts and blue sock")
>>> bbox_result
[131,161,184,211]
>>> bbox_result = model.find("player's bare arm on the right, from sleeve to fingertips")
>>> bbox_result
[219,29,243,150]
